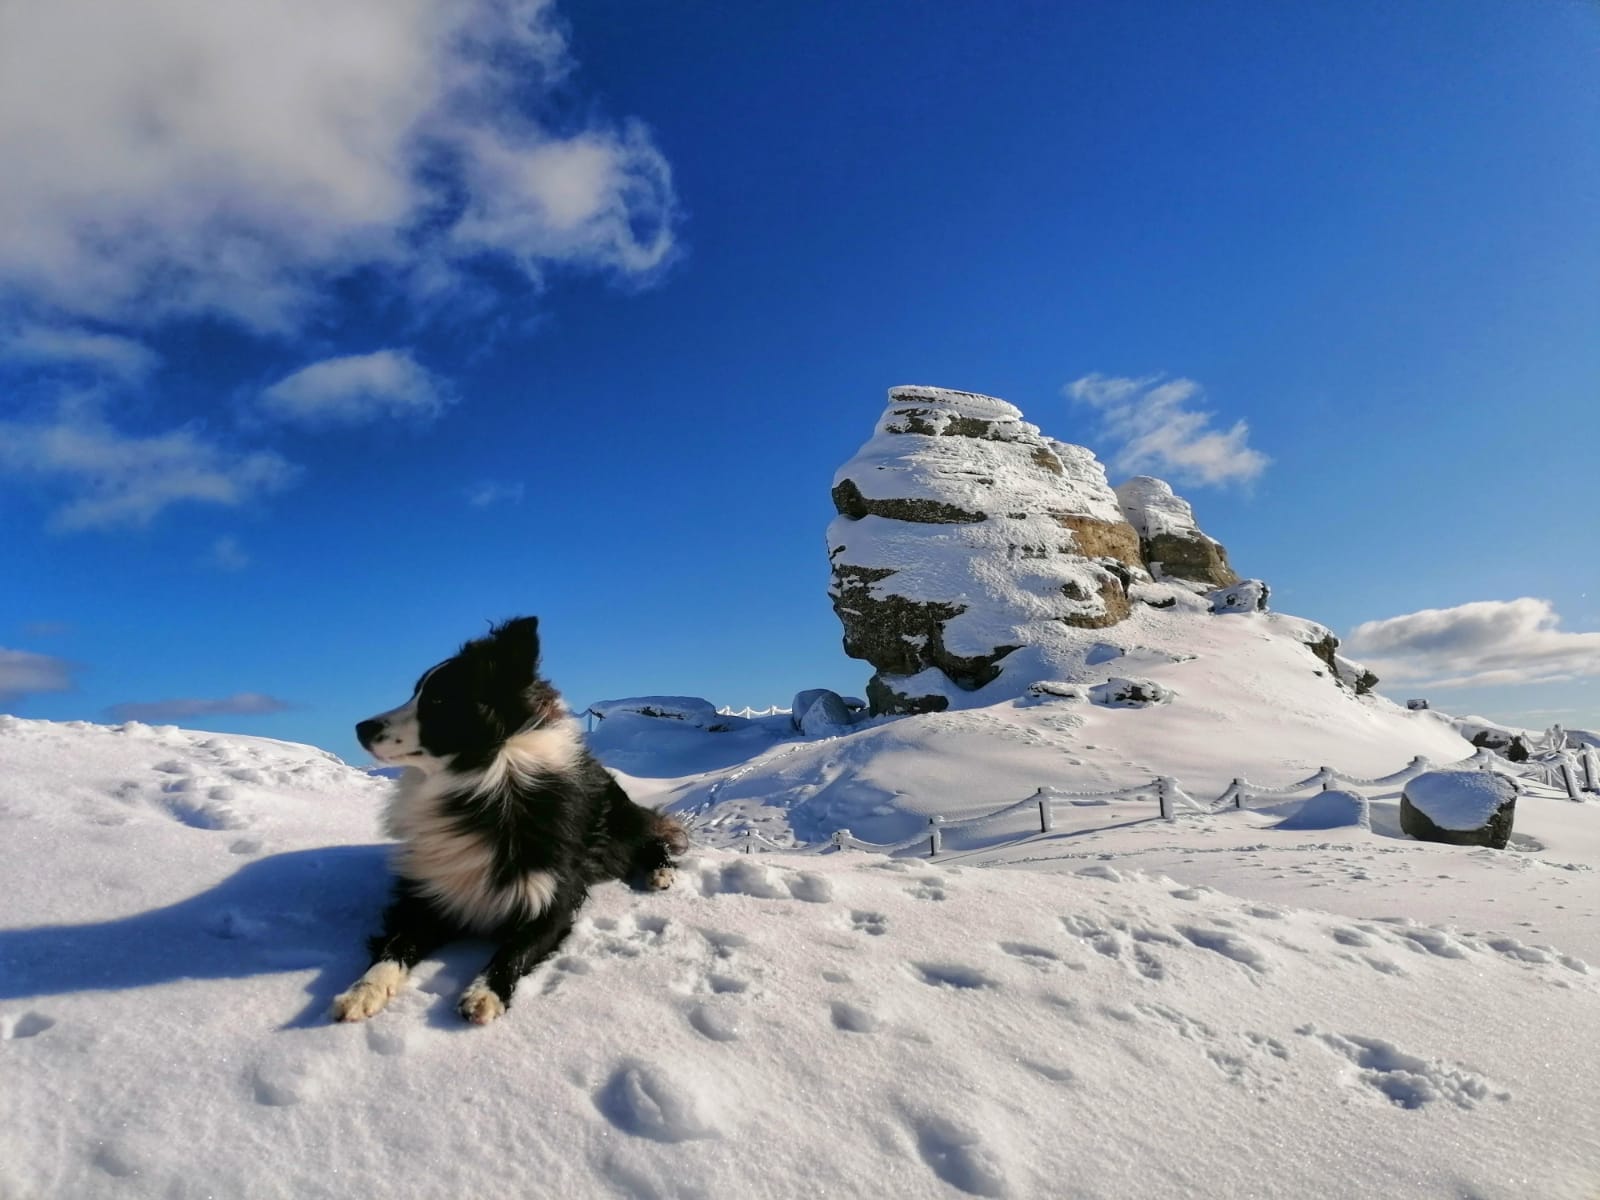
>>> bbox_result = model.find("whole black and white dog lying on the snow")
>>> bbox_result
[333,616,688,1026]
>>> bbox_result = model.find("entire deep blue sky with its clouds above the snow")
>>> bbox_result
[0,0,1600,760]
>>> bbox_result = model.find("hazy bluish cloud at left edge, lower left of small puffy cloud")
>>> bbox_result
[0,400,298,530]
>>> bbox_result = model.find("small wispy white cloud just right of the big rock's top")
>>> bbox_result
[1062,374,1270,483]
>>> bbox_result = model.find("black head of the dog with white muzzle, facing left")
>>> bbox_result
[355,616,555,774]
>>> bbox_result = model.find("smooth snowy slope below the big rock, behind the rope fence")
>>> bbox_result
[608,598,1472,842]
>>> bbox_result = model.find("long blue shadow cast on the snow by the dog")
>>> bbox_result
[0,845,406,1029]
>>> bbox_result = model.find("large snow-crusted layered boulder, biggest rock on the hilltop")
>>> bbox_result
[827,387,1152,712]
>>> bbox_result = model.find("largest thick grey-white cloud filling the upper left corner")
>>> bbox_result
[0,0,675,333]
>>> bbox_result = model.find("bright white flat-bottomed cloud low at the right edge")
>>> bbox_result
[1341,597,1600,688]
